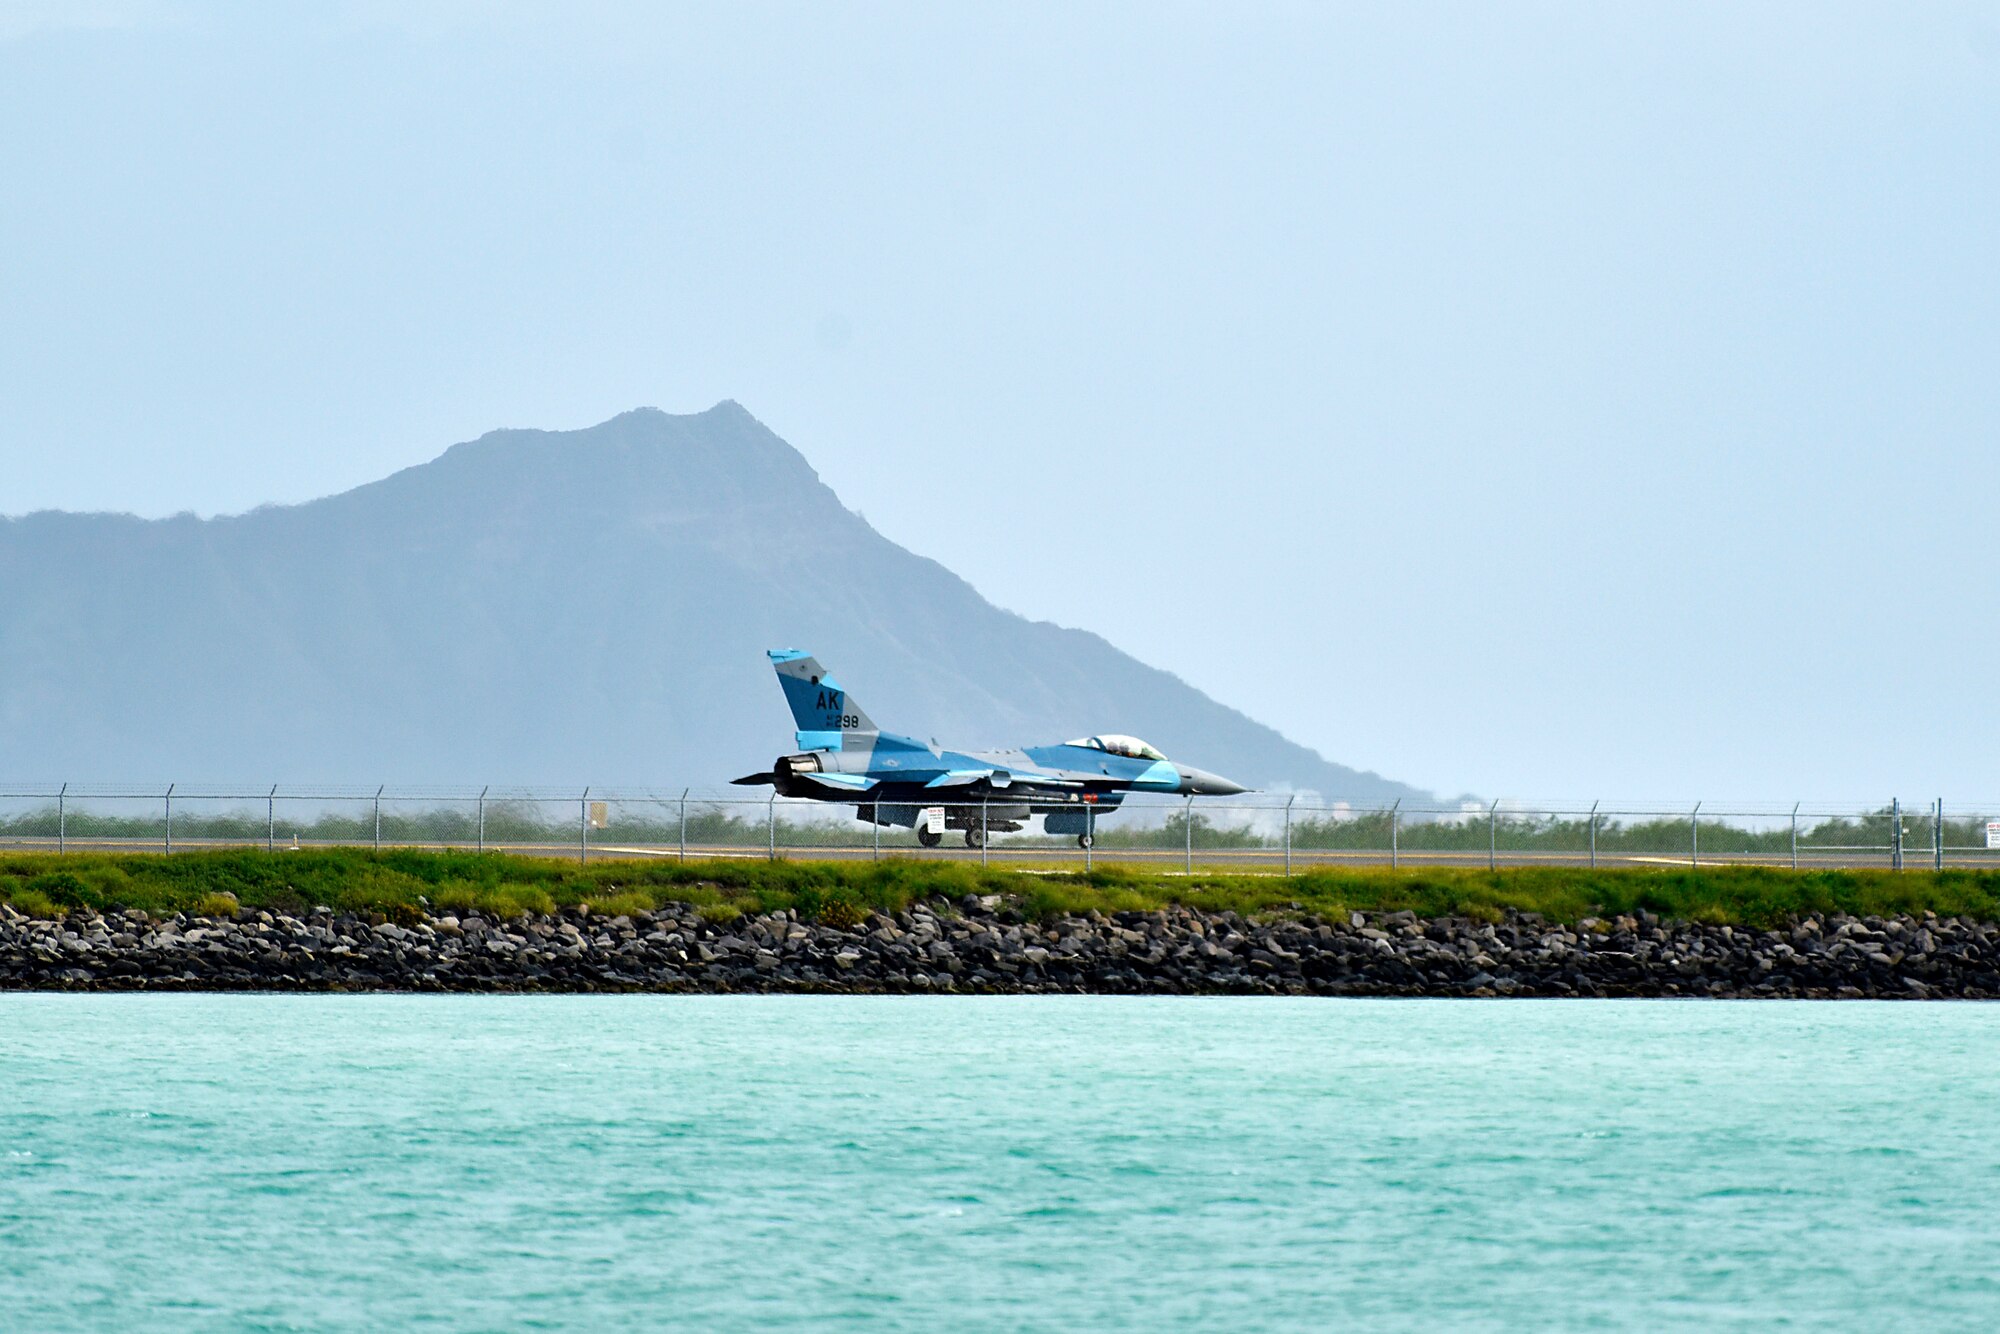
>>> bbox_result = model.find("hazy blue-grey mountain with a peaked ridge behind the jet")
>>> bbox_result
[0,400,1424,800]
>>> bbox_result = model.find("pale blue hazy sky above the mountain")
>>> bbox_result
[0,0,2000,802]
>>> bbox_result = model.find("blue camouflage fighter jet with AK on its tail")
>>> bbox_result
[736,648,1244,848]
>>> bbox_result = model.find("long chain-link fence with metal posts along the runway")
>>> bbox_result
[0,784,2000,872]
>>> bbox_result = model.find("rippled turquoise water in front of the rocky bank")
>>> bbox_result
[0,996,2000,1330]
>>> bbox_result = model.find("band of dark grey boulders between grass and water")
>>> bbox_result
[0,898,2000,1000]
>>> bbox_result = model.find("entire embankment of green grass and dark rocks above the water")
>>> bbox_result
[0,850,2000,998]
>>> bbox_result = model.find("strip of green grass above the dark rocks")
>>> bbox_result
[0,848,2000,926]
